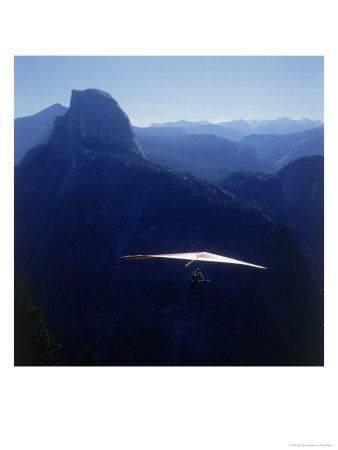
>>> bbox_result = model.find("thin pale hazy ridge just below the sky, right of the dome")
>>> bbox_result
[149,120,244,142]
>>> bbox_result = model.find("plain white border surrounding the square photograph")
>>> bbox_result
[0,0,338,450]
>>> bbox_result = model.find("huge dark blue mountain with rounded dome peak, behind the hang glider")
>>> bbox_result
[15,90,323,365]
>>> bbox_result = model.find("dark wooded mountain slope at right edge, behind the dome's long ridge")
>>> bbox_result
[220,155,324,286]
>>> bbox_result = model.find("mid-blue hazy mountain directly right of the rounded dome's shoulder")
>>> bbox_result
[138,133,272,181]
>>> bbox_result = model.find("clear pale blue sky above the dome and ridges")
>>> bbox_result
[14,56,324,126]
